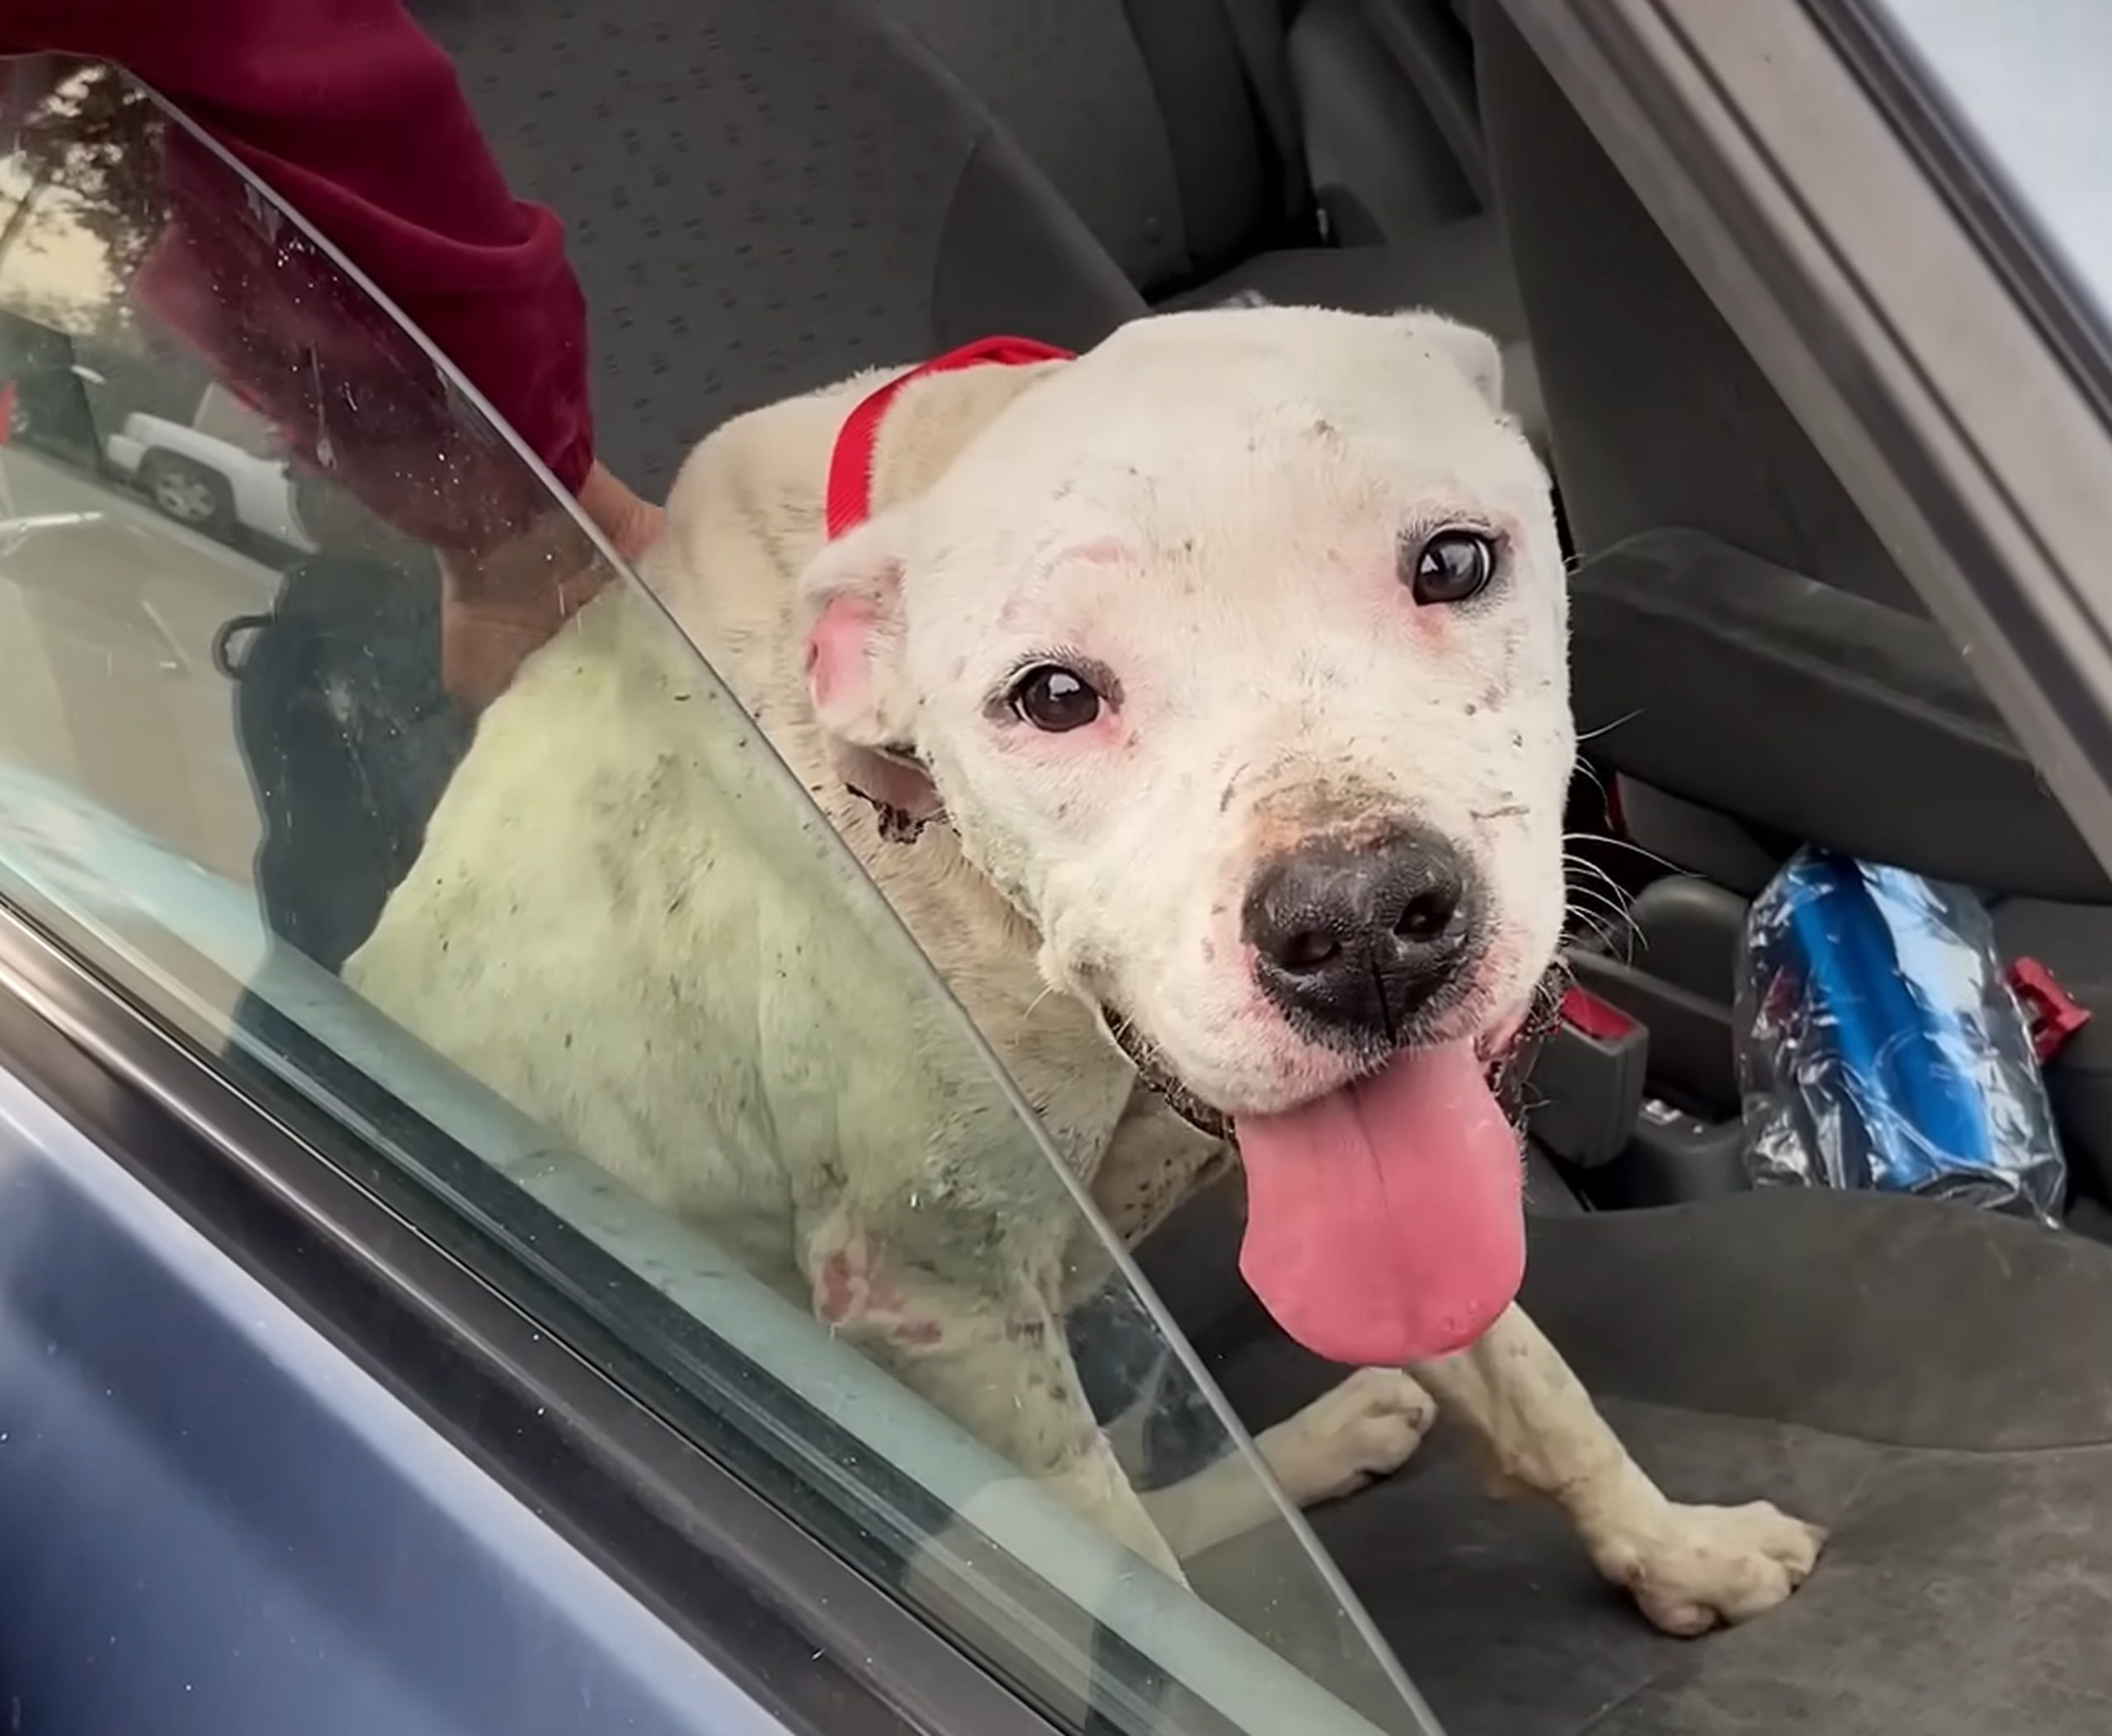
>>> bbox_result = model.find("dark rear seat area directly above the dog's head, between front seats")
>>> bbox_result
[849,0,1539,437]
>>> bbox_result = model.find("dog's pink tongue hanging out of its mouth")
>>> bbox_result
[1238,1043,1525,1366]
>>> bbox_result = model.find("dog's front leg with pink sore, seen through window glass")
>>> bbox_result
[807,1208,1183,1580]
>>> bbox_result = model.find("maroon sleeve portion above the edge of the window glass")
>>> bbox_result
[0,0,593,490]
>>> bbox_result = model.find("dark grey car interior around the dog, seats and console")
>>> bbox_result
[12,0,2112,1736]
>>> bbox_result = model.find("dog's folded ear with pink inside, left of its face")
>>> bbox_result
[800,507,940,832]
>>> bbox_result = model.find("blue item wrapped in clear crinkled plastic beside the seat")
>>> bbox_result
[1736,851,2067,1223]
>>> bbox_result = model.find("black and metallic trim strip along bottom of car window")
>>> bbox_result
[0,906,1072,1736]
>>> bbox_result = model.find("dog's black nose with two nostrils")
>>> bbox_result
[1244,830,1474,1041]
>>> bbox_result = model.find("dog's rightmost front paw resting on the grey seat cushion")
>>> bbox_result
[1592,1502,1827,1635]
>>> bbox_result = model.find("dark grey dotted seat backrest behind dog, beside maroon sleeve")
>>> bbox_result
[410,0,1143,497]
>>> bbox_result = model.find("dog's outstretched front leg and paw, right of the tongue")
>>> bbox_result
[1415,1307,1825,1635]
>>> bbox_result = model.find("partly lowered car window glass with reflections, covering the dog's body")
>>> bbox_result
[0,54,1423,1732]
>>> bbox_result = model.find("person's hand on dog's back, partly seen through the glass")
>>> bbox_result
[439,465,665,712]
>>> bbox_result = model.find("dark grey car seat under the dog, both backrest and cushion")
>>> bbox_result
[398,0,2112,1736]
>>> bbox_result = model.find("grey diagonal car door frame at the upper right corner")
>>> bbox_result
[1485,0,2112,891]
